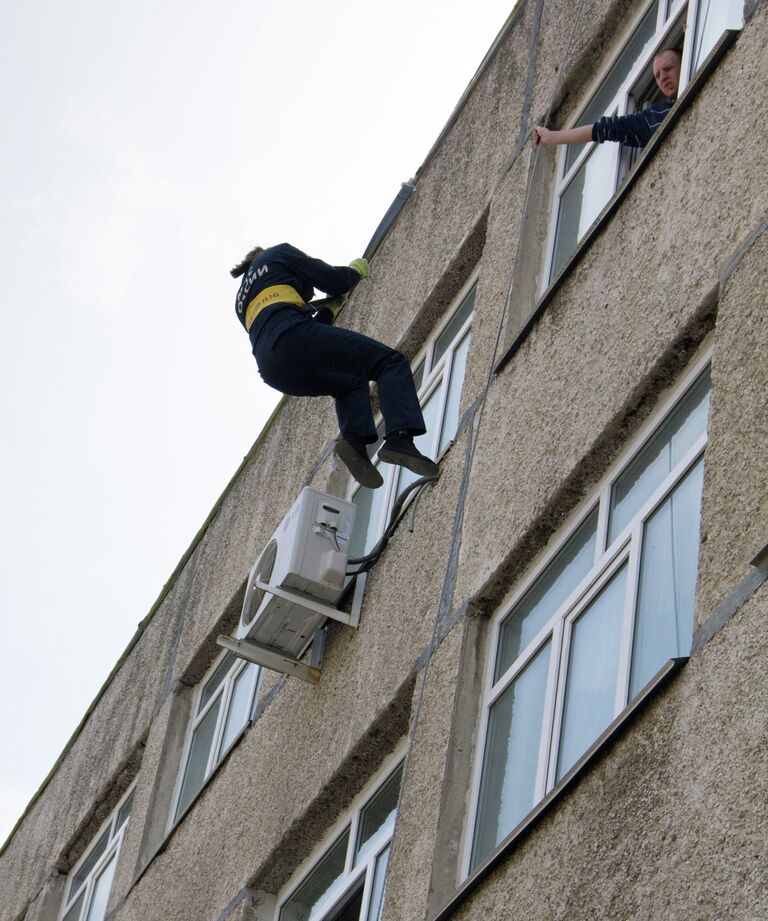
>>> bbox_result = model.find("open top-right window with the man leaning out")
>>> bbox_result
[542,0,743,288]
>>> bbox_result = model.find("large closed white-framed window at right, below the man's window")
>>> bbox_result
[463,344,710,875]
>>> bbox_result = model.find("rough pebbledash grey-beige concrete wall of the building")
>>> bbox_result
[0,0,768,921]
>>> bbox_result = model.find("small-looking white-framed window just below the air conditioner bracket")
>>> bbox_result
[169,652,260,826]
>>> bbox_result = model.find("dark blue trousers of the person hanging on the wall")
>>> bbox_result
[253,311,426,444]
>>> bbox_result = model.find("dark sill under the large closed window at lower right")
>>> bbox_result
[431,657,688,921]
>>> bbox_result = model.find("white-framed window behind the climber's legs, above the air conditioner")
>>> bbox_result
[349,276,477,557]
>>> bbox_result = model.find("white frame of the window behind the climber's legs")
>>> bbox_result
[348,269,480,552]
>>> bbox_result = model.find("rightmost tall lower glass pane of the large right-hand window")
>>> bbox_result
[629,458,704,700]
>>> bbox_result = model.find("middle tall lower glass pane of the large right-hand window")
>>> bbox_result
[557,564,627,780]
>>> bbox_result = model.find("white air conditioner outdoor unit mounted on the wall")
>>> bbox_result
[237,486,355,659]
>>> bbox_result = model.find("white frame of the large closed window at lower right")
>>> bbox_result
[460,342,712,878]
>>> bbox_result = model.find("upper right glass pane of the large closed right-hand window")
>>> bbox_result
[608,370,710,546]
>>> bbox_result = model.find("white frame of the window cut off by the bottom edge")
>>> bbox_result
[274,742,405,921]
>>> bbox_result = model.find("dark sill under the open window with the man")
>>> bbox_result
[494,29,740,374]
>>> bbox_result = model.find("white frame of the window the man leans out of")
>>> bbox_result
[541,0,743,293]
